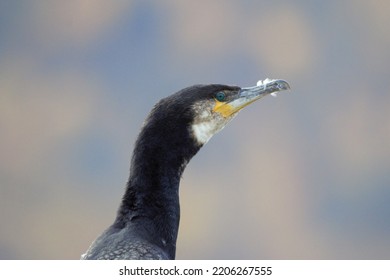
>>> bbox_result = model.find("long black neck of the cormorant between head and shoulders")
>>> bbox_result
[114,115,201,259]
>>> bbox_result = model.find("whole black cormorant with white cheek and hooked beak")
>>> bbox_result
[82,79,290,259]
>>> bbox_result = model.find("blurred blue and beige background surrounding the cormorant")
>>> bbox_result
[0,0,390,259]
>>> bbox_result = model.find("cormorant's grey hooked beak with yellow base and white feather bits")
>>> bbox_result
[214,79,290,117]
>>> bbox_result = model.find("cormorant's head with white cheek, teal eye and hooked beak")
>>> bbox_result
[140,79,290,155]
